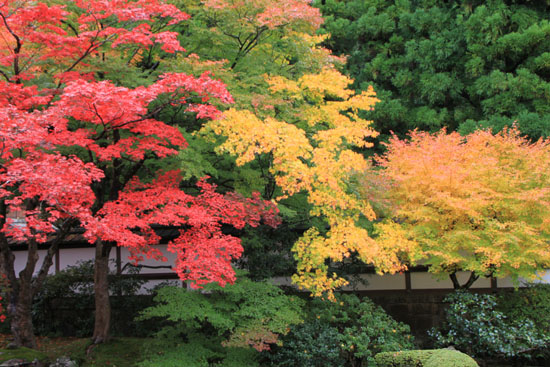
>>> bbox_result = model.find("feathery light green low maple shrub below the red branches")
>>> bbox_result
[140,277,303,367]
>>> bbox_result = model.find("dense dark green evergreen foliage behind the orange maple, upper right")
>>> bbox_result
[317,0,550,147]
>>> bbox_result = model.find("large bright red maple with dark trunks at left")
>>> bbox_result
[0,0,277,347]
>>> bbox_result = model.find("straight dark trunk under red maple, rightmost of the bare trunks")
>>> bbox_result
[92,240,111,344]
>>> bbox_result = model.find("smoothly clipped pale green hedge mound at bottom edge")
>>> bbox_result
[374,349,478,367]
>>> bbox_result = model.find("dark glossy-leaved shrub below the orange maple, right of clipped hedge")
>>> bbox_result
[429,291,549,358]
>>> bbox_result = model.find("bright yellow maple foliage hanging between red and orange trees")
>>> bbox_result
[203,67,410,298]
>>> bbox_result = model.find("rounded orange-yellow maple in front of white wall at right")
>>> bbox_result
[376,129,550,288]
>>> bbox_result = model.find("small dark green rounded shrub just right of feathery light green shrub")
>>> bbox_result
[268,319,345,367]
